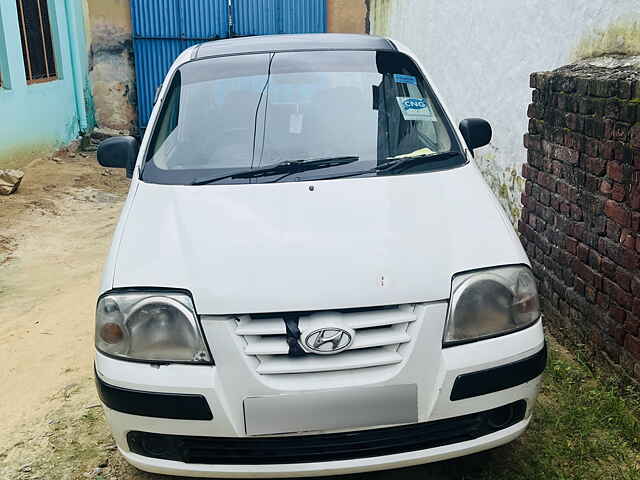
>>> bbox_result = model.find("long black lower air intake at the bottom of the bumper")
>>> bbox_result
[127,400,527,465]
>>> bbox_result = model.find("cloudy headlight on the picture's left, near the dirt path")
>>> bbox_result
[95,292,211,364]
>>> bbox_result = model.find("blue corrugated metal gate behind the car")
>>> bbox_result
[131,0,327,129]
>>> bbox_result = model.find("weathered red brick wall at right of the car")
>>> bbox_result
[519,65,640,379]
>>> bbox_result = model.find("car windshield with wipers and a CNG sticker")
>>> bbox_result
[142,51,465,185]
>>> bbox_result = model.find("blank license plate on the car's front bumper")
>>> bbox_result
[244,384,418,435]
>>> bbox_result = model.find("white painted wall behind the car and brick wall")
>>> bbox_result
[370,0,640,219]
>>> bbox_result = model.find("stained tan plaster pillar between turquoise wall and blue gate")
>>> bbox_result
[86,0,136,131]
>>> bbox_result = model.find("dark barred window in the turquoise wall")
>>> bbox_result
[16,0,60,85]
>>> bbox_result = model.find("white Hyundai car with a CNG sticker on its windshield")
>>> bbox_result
[95,34,546,477]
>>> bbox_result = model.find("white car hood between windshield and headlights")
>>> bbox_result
[111,164,528,314]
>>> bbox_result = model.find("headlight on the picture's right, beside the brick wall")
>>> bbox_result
[443,266,540,346]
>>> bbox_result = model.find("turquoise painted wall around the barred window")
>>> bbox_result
[0,0,93,168]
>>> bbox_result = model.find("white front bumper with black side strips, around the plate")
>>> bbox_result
[96,316,546,477]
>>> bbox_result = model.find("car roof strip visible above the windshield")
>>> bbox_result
[192,33,396,59]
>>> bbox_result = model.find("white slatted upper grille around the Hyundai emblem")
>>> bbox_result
[235,305,417,375]
